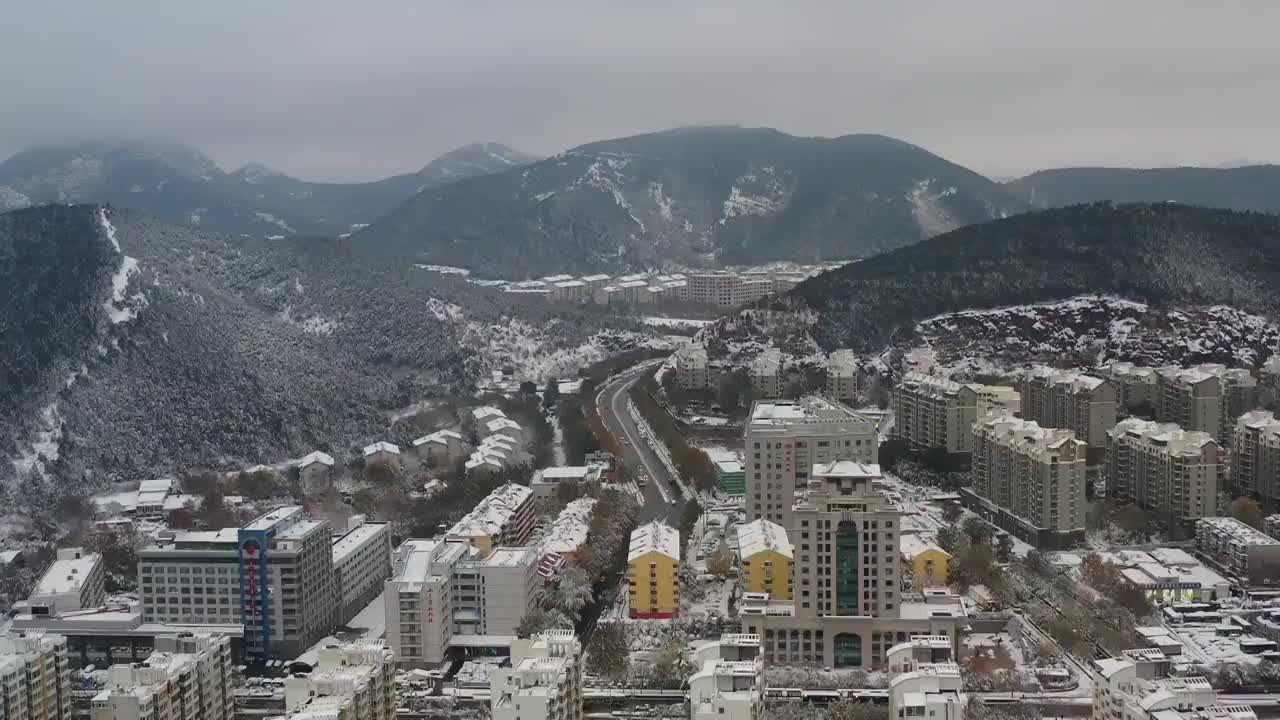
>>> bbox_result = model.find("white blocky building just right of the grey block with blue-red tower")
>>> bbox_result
[384,539,541,667]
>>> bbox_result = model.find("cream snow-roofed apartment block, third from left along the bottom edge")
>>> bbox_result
[280,641,396,720]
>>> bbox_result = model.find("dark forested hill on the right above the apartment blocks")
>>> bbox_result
[794,202,1280,351]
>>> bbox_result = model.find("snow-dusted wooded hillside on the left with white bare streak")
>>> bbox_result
[0,199,634,487]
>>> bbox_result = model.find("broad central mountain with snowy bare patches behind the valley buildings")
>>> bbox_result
[352,127,1029,277]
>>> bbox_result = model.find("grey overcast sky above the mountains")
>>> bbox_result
[0,0,1280,179]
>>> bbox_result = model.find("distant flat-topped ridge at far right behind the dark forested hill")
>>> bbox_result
[1005,165,1280,213]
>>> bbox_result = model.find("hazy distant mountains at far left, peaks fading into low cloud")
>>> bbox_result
[0,141,534,238]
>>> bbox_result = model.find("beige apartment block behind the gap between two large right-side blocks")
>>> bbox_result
[1018,366,1119,456]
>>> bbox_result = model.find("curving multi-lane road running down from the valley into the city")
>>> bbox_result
[595,360,687,528]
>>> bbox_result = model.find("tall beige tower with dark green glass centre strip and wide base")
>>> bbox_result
[740,460,968,669]
